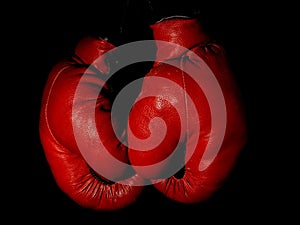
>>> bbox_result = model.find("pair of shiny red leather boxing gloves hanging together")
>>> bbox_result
[40,17,247,210]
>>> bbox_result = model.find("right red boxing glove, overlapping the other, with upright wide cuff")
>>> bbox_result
[128,17,247,203]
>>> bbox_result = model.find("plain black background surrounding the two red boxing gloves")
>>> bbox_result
[4,0,295,224]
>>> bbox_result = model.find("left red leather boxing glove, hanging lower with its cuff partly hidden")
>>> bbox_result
[40,37,142,210]
